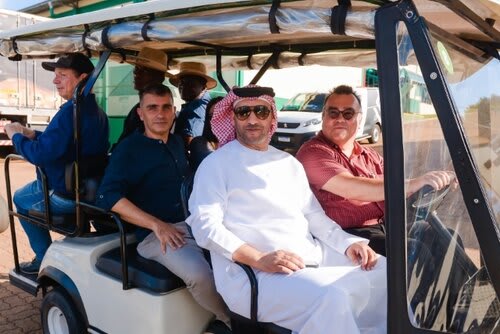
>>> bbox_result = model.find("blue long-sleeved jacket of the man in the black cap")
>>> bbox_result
[12,94,109,195]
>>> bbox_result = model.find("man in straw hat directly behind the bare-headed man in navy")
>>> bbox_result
[117,47,170,143]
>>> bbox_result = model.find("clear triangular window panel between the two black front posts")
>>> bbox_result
[399,24,500,333]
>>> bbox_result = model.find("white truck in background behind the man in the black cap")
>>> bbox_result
[0,9,61,146]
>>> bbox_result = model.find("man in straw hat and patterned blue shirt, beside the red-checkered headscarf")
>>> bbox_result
[170,62,217,147]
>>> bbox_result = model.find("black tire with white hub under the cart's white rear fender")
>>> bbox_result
[40,287,87,334]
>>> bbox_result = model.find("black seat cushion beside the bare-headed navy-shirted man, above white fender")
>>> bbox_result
[96,243,186,293]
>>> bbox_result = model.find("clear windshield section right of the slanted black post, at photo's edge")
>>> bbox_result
[435,45,500,227]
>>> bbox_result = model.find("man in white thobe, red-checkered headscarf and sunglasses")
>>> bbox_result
[187,86,387,334]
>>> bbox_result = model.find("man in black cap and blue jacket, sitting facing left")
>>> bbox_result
[5,53,109,274]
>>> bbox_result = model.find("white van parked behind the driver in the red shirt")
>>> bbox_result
[271,87,382,153]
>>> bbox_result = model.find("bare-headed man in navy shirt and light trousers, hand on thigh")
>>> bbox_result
[96,84,229,333]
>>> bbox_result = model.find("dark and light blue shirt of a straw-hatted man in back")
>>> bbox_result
[174,92,210,137]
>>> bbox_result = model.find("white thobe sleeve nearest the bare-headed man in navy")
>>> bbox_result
[186,156,244,260]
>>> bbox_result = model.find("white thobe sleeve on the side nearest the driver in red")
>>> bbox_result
[297,162,369,254]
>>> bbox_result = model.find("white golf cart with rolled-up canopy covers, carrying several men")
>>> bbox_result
[0,0,500,334]
